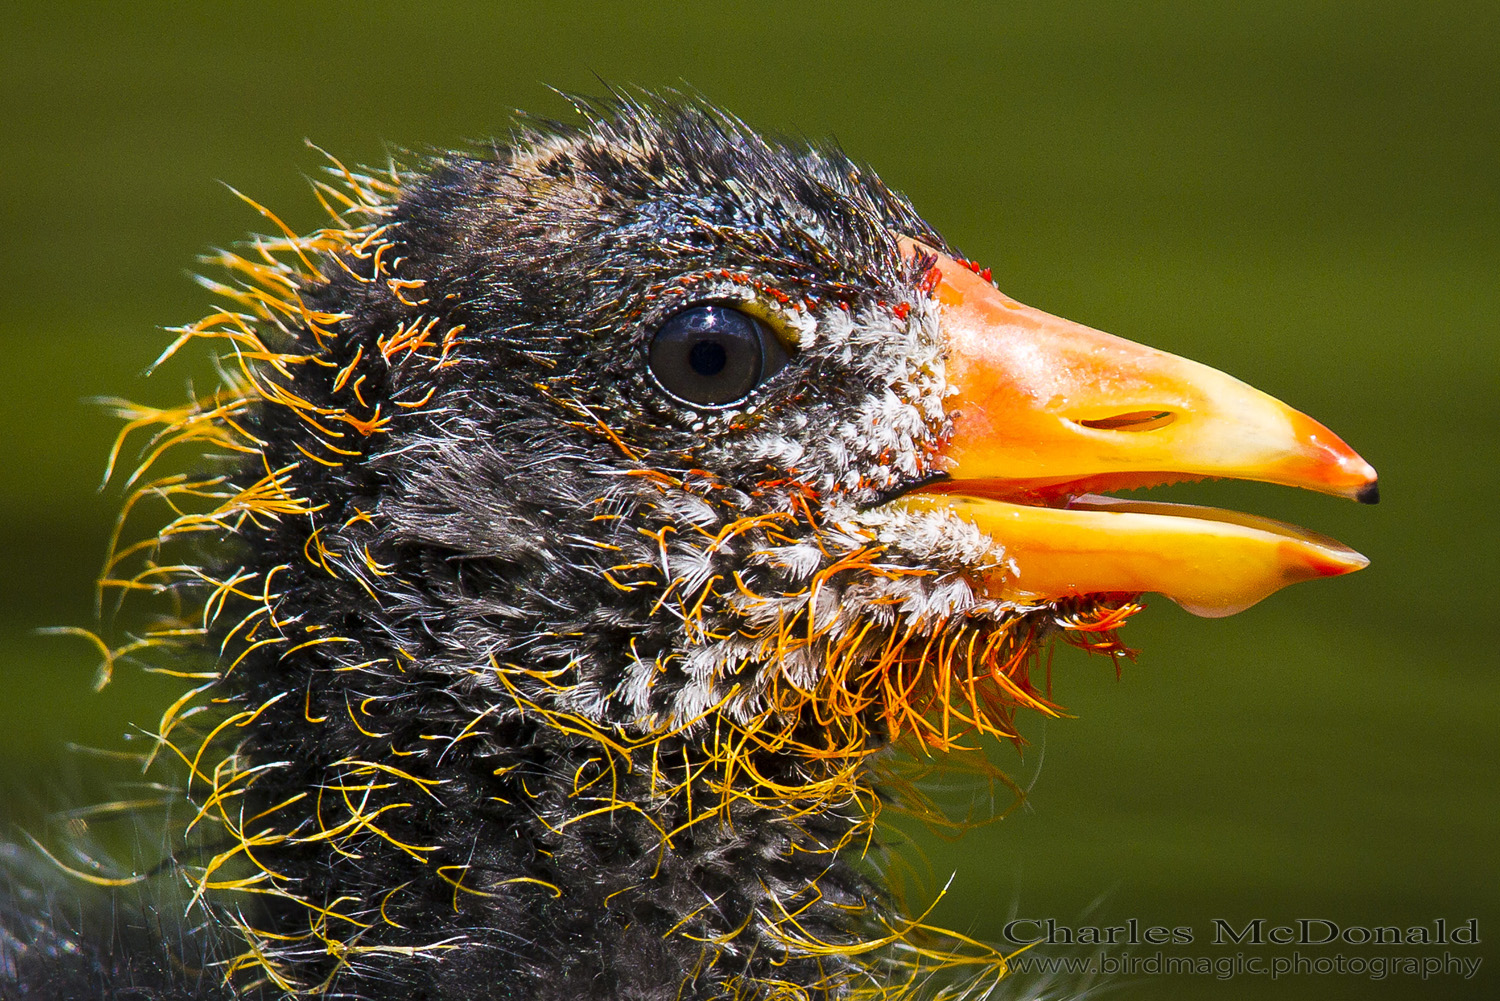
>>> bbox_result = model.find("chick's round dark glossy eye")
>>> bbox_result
[648,306,791,407]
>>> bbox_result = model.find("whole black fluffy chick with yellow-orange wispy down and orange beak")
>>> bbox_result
[0,99,1376,1001]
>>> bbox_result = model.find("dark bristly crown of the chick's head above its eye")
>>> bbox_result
[398,101,945,316]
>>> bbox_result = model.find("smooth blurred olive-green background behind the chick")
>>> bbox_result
[0,0,1500,998]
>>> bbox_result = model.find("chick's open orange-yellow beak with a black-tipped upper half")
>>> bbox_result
[893,242,1379,615]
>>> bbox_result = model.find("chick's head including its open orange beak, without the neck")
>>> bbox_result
[348,102,1376,738]
